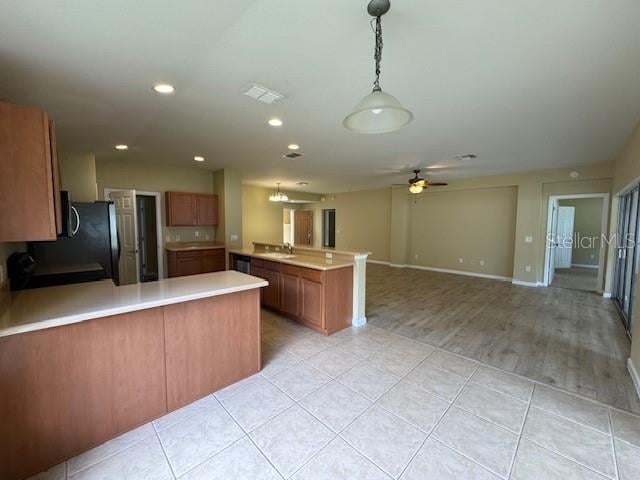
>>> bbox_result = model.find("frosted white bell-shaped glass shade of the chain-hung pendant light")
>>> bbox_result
[342,90,413,134]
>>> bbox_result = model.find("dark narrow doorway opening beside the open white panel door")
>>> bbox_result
[136,194,158,282]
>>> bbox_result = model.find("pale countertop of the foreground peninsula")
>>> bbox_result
[0,271,268,337]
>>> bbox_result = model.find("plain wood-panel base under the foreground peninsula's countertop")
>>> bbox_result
[0,289,260,480]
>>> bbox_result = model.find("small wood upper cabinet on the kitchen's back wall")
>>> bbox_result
[166,192,218,227]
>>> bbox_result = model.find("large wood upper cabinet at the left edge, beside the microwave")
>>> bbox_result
[0,102,62,242]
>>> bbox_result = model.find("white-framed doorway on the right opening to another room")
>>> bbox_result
[543,193,609,292]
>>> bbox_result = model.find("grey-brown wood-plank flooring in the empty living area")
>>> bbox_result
[367,264,640,413]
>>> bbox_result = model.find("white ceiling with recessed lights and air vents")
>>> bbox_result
[0,0,640,192]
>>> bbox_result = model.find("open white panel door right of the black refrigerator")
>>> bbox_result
[109,190,140,285]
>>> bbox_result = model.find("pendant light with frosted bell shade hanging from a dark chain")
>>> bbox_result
[342,0,413,134]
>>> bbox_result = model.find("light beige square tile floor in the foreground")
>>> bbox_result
[35,312,640,480]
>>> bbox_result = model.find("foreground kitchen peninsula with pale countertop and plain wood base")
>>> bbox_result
[0,271,267,480]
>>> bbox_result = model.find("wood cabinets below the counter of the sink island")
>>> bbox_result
[235,255,353,335]
